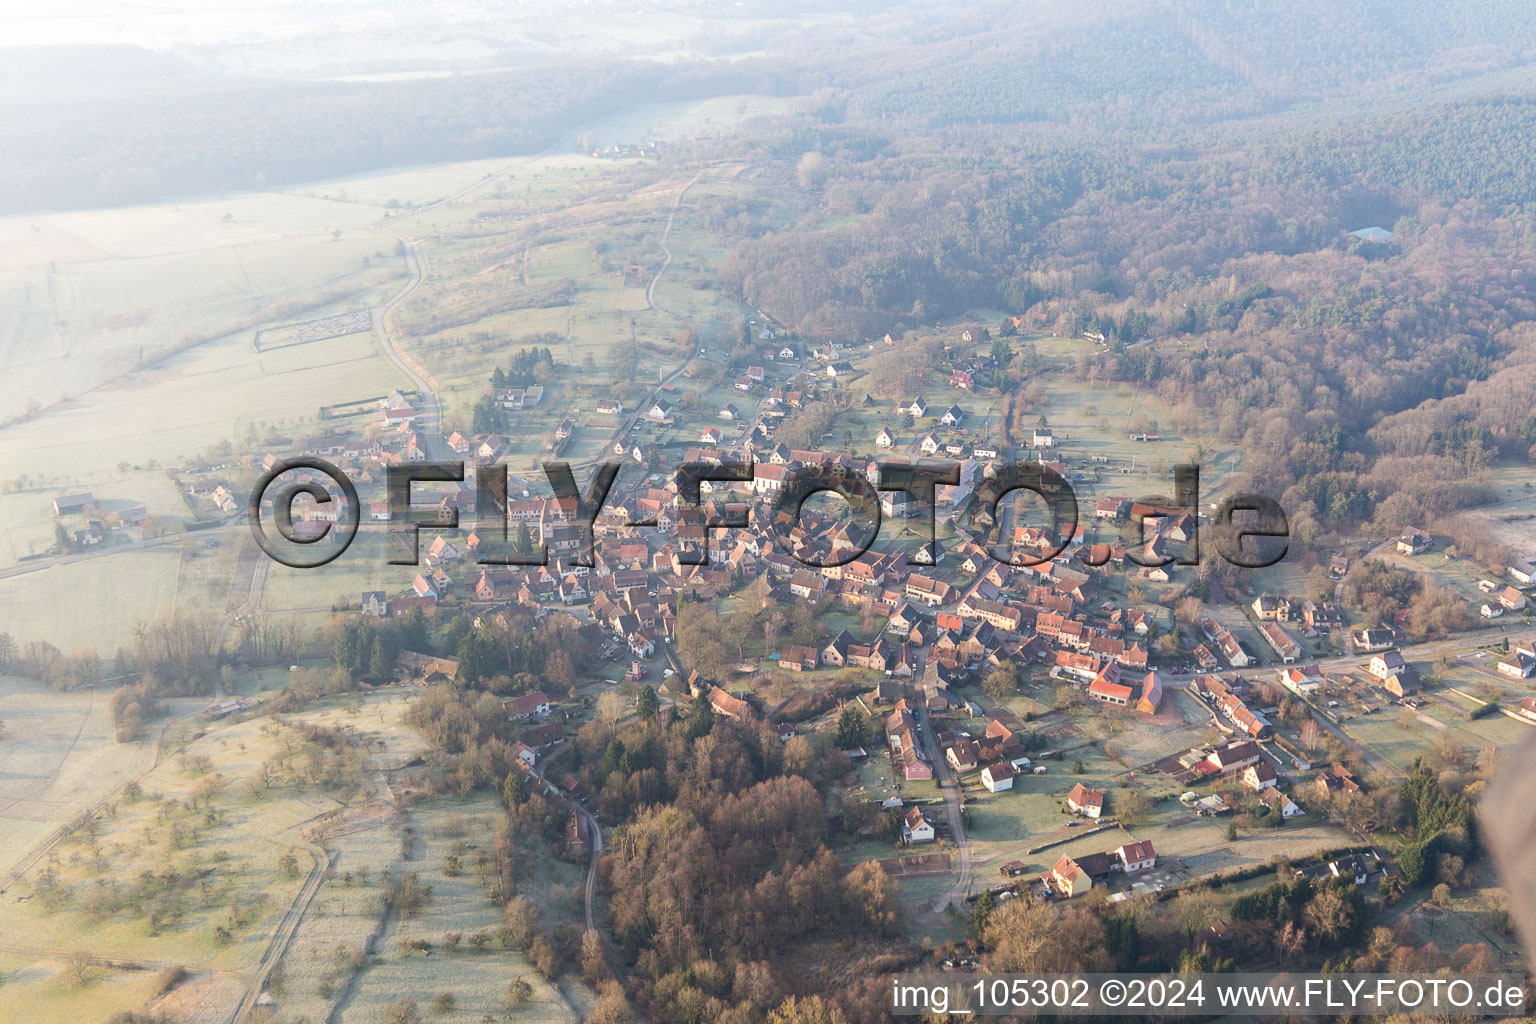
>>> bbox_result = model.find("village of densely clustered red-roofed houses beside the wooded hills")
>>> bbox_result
[74,313,1536,927]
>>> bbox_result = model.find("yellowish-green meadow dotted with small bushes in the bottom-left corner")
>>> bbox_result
[0,692,439,1009]
